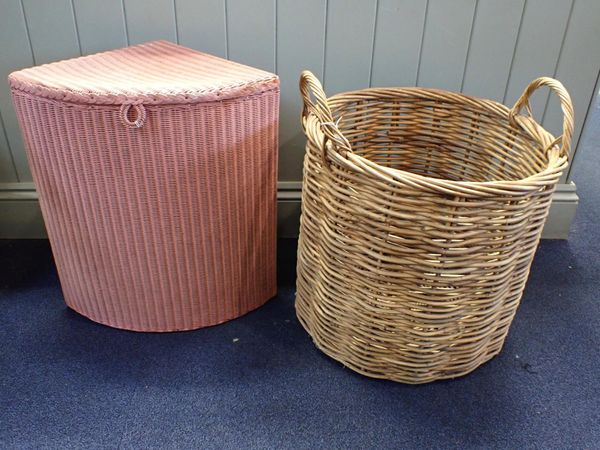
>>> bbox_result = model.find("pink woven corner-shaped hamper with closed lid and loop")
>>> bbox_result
[9,41,279,331]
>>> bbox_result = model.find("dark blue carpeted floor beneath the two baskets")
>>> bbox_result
[0,103,600,449]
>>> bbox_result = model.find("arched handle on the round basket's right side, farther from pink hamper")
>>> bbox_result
[508,77,574,157]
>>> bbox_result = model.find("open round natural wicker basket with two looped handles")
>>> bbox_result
[296,72,573,383]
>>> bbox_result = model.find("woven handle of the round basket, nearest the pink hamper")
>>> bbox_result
[300,70,352,167]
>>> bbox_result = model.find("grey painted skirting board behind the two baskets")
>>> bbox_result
[0,181,579,239]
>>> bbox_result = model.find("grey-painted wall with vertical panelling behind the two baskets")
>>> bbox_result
[0,0,600,183]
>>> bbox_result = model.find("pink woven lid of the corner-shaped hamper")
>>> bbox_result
[8,41,279,105]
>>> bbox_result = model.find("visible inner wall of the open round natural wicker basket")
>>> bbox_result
[331,93,548,182]
